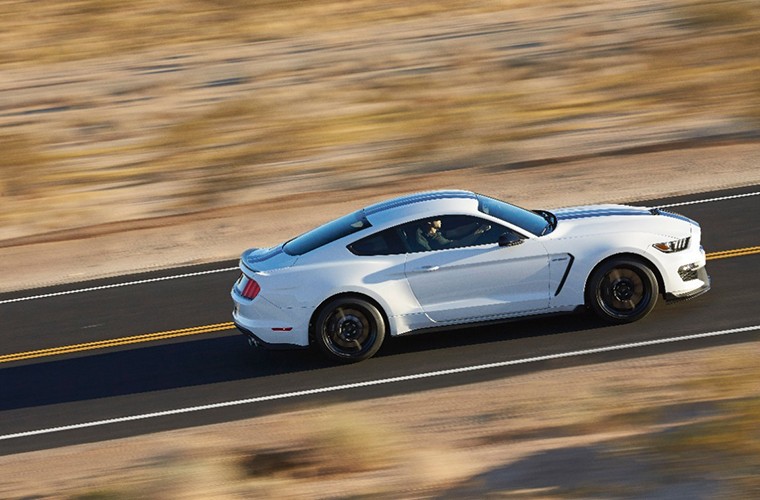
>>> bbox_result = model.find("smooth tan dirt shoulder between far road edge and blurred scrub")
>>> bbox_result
[0,142,760,292]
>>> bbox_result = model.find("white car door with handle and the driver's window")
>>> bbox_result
[404,215,549,323]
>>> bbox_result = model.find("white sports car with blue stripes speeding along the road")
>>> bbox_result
[232,191,710,362]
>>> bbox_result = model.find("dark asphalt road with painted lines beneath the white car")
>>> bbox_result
[0,186,760,454]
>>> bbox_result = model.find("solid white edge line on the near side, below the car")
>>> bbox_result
[0,325,760,441]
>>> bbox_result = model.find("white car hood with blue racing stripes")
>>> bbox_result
[552,205,698,238]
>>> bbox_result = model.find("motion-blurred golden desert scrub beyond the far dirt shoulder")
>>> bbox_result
[0,0,760,241]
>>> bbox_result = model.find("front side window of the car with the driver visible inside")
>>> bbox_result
[399,215,509,252]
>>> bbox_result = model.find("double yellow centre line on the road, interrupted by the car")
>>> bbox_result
[0,246,760,363]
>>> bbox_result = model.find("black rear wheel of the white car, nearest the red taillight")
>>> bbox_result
[314,297,385,363]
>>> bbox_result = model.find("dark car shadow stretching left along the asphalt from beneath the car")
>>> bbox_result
[0,315,604,411]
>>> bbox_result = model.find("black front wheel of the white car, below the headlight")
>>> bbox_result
[586,258,659,323]
